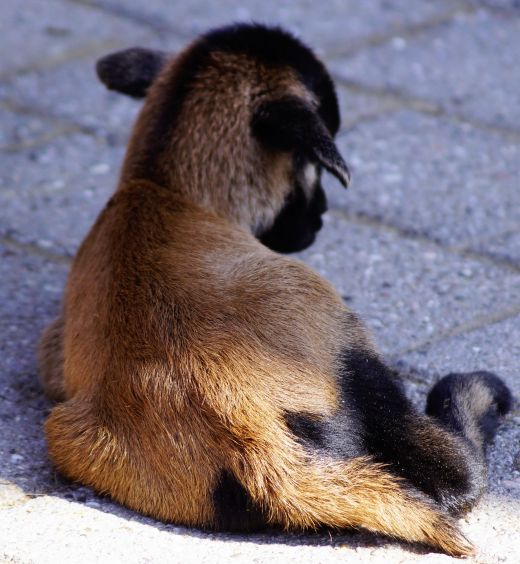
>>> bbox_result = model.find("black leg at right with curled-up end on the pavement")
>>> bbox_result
[344,355,510,514]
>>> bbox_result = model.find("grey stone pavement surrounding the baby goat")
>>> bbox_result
[0,0,520,564]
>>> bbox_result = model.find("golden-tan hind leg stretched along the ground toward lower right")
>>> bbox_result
[225,412,472,556]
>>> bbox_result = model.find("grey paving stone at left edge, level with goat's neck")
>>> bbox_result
[0,134,124,255]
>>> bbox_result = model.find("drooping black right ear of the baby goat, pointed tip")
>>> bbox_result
[251,97,350,187]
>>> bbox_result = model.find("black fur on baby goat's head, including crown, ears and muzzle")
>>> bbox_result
[97,24,350,252]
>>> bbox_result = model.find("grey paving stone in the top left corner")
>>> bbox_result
[0,0,150,77]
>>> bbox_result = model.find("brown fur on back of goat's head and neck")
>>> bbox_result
[123,49,315,231]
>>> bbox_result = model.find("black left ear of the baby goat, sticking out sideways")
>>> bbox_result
[96,47,169,98]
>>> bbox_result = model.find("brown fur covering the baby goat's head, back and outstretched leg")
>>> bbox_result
[40,33,471,555]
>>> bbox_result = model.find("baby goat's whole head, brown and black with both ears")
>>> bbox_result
[97,24,349,252]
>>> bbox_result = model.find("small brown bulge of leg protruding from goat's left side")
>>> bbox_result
[38,317,66,402]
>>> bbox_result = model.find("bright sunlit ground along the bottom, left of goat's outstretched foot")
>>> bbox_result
[0,497,426,564]
